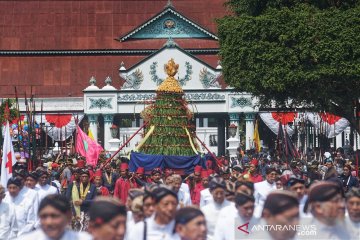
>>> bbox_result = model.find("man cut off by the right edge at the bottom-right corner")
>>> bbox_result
[345,187,360,239]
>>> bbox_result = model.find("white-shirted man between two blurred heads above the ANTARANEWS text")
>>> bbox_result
[254,167,277,218]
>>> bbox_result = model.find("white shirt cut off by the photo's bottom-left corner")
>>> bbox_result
[0,202,17,240]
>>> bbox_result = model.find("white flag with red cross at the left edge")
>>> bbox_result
[1,121,16,187]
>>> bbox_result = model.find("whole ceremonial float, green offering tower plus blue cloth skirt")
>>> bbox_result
[129,59,205,173]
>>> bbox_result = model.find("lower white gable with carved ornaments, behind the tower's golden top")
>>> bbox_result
[119,39,221,91]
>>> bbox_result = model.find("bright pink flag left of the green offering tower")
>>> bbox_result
[76,126,104,166]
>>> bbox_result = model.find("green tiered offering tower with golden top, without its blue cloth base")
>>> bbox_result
[136,59,198,156]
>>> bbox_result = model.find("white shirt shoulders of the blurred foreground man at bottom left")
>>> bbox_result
[18,229,93,240]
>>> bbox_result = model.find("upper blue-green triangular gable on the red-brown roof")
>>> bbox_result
[119,6,218,42]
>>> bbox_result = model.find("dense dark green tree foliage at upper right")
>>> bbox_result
[218,0,360,131]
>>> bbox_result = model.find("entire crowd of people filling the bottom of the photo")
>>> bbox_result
[0,148,360,240]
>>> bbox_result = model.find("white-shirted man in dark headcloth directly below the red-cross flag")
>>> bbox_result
[4,177,37,237]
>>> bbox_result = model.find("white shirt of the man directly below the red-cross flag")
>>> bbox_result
[3,187,38,237]
